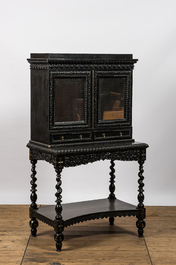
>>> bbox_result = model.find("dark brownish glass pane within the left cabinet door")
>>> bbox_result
[54,77,84,122]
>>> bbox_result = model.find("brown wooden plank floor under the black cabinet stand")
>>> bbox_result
[0,205,176,265]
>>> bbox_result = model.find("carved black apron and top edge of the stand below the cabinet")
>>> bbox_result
[28,143,148,167]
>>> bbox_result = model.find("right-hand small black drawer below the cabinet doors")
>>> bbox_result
[94,128,132,140]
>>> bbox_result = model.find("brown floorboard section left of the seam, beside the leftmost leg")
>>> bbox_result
[0,205,30,265]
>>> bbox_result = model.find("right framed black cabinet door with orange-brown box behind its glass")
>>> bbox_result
[94,71,132,128]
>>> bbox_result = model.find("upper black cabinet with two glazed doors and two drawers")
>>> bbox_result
[28,54,137,145]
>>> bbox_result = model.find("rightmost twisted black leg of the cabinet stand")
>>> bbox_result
[136,160,145,237]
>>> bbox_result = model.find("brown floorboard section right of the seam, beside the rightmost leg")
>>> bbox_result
[145,207,176,265]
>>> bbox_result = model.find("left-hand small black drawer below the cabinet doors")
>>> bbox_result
[50,132,92,143]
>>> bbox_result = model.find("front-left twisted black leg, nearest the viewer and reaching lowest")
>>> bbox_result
[54,159,64,251]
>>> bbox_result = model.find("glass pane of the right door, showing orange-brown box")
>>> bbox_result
[99,76,125,120]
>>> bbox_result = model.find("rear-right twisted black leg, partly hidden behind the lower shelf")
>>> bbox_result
[109,160,116,225]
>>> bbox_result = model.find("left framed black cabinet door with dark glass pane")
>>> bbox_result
[50,71,91,130]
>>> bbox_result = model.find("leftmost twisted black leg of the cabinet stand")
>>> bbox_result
[29,159,38,236]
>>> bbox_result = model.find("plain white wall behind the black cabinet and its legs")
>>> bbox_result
[0,0,176,205]
